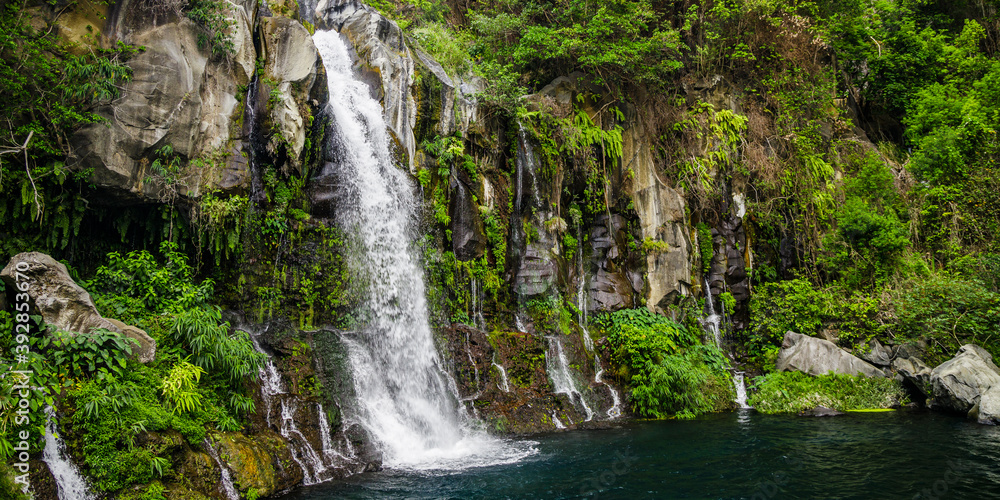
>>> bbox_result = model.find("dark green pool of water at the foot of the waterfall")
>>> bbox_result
[284,412,1000,500]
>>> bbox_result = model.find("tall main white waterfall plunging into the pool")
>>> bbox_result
[313,31,534,469]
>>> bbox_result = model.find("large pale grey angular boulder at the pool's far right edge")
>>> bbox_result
[928,344,1000,413]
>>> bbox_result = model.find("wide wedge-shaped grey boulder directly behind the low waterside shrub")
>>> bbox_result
[775,332,885,377]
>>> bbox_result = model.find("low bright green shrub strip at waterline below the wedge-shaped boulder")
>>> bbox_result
[748,372,906,413]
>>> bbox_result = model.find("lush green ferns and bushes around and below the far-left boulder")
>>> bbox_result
[0,243,264,493]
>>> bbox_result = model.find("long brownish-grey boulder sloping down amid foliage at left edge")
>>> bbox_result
[0,252,156,363]
